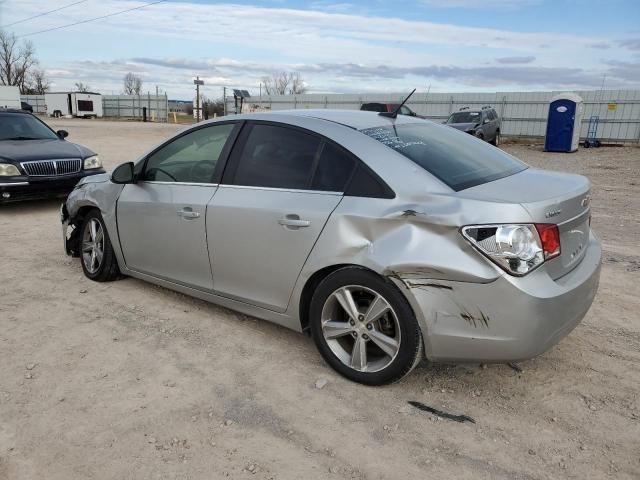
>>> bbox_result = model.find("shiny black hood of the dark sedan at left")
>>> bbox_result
[0,139,95,162]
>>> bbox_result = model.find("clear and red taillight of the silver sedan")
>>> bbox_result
[462,224,560,276]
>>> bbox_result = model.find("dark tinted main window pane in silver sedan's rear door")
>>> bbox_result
[233,124,320,190]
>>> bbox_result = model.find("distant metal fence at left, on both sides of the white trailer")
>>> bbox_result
[21,94,169,122]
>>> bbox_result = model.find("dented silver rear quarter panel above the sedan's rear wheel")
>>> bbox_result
[298,193,529,356]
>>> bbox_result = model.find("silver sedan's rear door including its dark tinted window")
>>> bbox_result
[207,122,355,312]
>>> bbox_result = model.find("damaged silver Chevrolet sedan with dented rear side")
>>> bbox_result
[61,110,601,385]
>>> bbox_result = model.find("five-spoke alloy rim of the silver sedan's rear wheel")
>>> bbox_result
[321,285,401,372]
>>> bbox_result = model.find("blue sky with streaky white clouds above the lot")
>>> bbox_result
[0,0,640,98]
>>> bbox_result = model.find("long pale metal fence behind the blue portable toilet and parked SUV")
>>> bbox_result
[226,90,640,142]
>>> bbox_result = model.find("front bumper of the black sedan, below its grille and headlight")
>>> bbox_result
[0,168,105,203]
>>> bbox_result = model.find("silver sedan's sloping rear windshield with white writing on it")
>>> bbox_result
[361,122,527,191]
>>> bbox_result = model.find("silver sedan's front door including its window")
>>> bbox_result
[117,123,236,291]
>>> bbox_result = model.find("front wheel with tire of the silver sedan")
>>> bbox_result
[79,210,121,282]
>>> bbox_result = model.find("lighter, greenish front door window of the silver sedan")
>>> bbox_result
[143,123,234,183]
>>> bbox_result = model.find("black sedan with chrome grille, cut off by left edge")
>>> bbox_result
[0,109,104,203]
